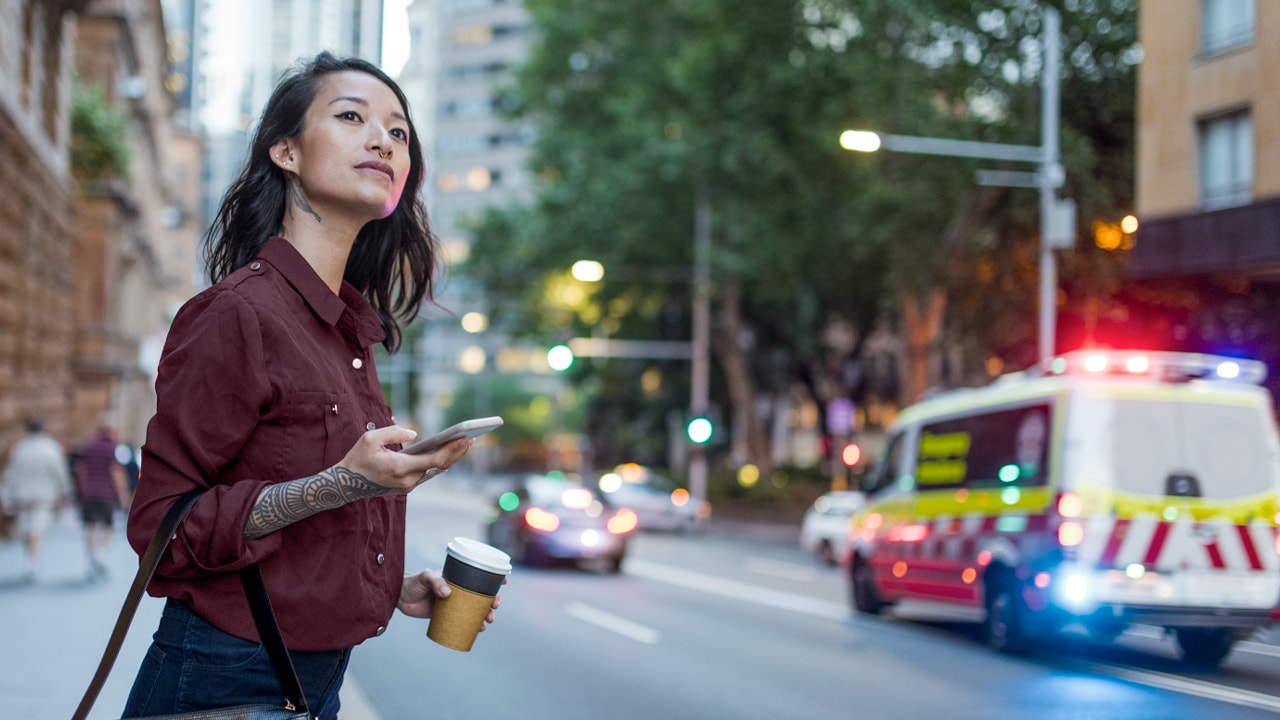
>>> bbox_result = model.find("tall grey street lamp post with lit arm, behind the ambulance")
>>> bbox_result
[840,8,1075,363]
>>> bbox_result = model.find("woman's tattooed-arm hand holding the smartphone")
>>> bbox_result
[338,425,475,495]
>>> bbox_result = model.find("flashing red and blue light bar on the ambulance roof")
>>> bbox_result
[1042,350,1267,384]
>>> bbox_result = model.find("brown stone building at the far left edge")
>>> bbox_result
[0,0,86,452]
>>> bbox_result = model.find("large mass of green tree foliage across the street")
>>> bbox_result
[461,0,1137,453]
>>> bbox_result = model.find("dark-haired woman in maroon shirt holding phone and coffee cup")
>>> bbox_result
[124,53,498,719]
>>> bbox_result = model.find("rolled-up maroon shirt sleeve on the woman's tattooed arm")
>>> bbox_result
[128,292,284,579]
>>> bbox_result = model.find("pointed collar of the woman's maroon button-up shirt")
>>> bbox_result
[257,236,387,346]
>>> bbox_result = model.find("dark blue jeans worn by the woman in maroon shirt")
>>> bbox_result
[123,600,351,720]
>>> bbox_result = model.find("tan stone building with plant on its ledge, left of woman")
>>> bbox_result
[70,0,201,445]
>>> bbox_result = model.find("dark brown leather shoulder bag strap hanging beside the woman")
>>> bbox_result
[72,489,308,720]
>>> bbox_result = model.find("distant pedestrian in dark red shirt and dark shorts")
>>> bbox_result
[74,419,129,578]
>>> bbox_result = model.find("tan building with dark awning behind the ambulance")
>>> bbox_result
[1129,0,1280,400]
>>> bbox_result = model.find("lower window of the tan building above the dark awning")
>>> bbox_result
[1199,111,1253,210]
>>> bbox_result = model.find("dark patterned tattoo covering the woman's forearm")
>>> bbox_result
[244,466,392,539]
